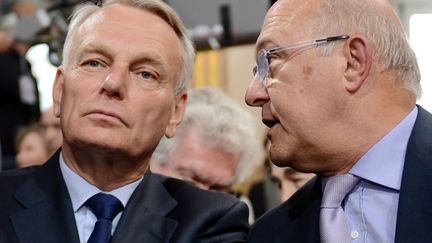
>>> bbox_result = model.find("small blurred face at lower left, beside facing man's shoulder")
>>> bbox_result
[15,124,50,168]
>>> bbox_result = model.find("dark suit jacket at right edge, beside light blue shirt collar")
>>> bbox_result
[395,107,432,243]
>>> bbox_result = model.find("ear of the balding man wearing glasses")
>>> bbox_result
[345,36,372,92]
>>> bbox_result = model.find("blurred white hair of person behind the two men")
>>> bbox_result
[152,87,264,184]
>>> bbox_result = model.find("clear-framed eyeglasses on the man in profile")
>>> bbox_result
[252,35,349,81]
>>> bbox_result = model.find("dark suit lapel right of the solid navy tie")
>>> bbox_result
[111,172,177,243]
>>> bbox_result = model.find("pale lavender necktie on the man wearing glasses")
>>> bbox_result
[320,174,358,243]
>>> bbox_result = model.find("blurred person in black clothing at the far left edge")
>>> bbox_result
[0,0,47,169]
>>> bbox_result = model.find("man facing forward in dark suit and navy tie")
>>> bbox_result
[0,0,248,243]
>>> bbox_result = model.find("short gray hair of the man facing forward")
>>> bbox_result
[63,0,195,93]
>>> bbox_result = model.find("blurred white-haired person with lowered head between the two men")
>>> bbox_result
[151,87,264,221]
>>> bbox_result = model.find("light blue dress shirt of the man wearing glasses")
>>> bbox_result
[343,107,418,243]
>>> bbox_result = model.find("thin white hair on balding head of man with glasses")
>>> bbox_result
[263,0,421,100]
